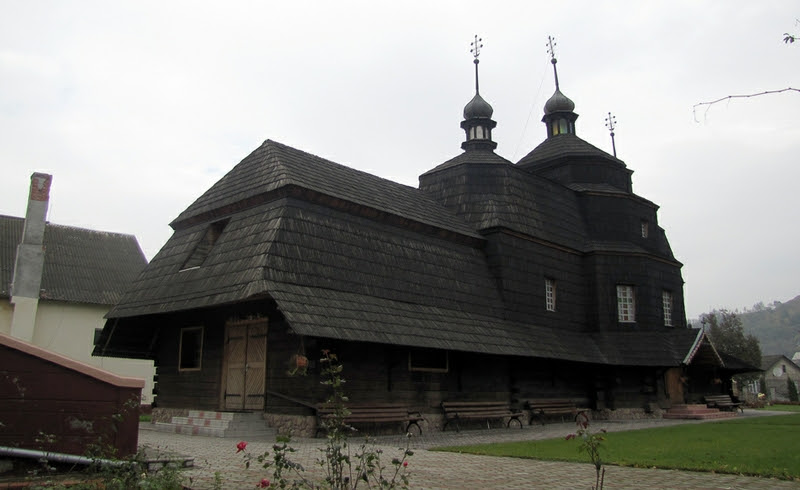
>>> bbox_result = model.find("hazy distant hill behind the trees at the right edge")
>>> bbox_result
[690,296,800,359]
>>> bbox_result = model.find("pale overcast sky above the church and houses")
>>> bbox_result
[0,0,800,318]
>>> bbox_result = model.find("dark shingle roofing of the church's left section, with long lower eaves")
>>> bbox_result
[107,141,692,366]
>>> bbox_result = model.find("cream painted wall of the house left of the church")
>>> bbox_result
[0,299,155,404]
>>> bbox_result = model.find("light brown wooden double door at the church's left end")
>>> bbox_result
[222,319,267,410]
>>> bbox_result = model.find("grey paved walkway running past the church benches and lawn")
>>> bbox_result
[139,411,800,490]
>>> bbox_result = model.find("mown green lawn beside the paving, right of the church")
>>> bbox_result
[436,415,800,480]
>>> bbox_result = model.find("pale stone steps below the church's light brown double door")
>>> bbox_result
[152,410,275,440]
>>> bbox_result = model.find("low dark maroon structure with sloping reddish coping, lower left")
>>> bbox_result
[0,334,144,457]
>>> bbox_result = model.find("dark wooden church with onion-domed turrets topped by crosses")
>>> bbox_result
[95,40,726,434]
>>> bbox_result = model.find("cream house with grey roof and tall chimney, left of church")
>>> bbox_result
[0,172,154,404]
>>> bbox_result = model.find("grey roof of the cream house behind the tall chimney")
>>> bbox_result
[0,215,147,305]
